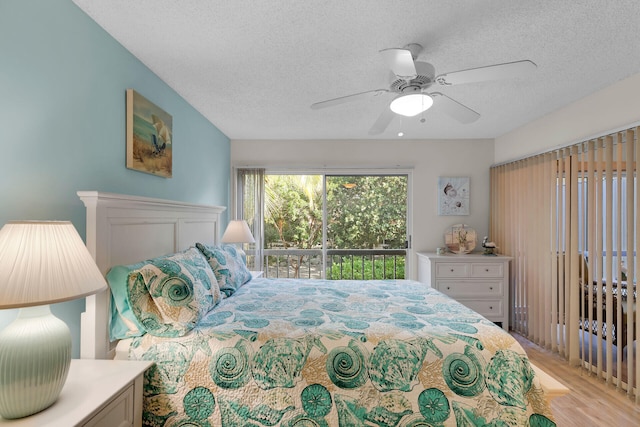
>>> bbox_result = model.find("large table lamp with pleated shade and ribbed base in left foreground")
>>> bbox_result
[0,221,106,419]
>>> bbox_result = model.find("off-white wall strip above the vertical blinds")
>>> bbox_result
[495,74,640,163]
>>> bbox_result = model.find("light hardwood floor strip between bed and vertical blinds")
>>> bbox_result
[512,333,640,427]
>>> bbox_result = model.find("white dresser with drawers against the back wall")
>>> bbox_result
[417,252,511,331]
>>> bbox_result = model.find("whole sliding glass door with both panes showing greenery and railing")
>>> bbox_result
[263,171,409,279]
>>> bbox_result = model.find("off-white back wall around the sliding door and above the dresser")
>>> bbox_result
[231,139,494,278]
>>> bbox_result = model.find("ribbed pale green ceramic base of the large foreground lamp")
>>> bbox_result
[0,305,71,419]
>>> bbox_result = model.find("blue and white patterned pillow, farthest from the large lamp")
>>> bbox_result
[196,243,251,297]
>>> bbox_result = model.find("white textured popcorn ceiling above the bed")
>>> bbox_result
[73,0,640,139]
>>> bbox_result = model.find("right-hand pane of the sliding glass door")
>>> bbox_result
[325,175,408,280]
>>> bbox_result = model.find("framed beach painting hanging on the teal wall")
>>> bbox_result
[127,89,173,178]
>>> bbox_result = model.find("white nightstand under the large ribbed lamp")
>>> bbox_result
[0,359,153,427]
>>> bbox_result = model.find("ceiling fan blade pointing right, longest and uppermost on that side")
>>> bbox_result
[436,60,538,86]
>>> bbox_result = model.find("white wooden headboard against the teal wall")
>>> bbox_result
[78,191,226,359]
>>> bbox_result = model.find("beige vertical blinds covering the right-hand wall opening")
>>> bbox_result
[490,127,640,402]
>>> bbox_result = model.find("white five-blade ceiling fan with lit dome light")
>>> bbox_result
[311,43,537,135]
